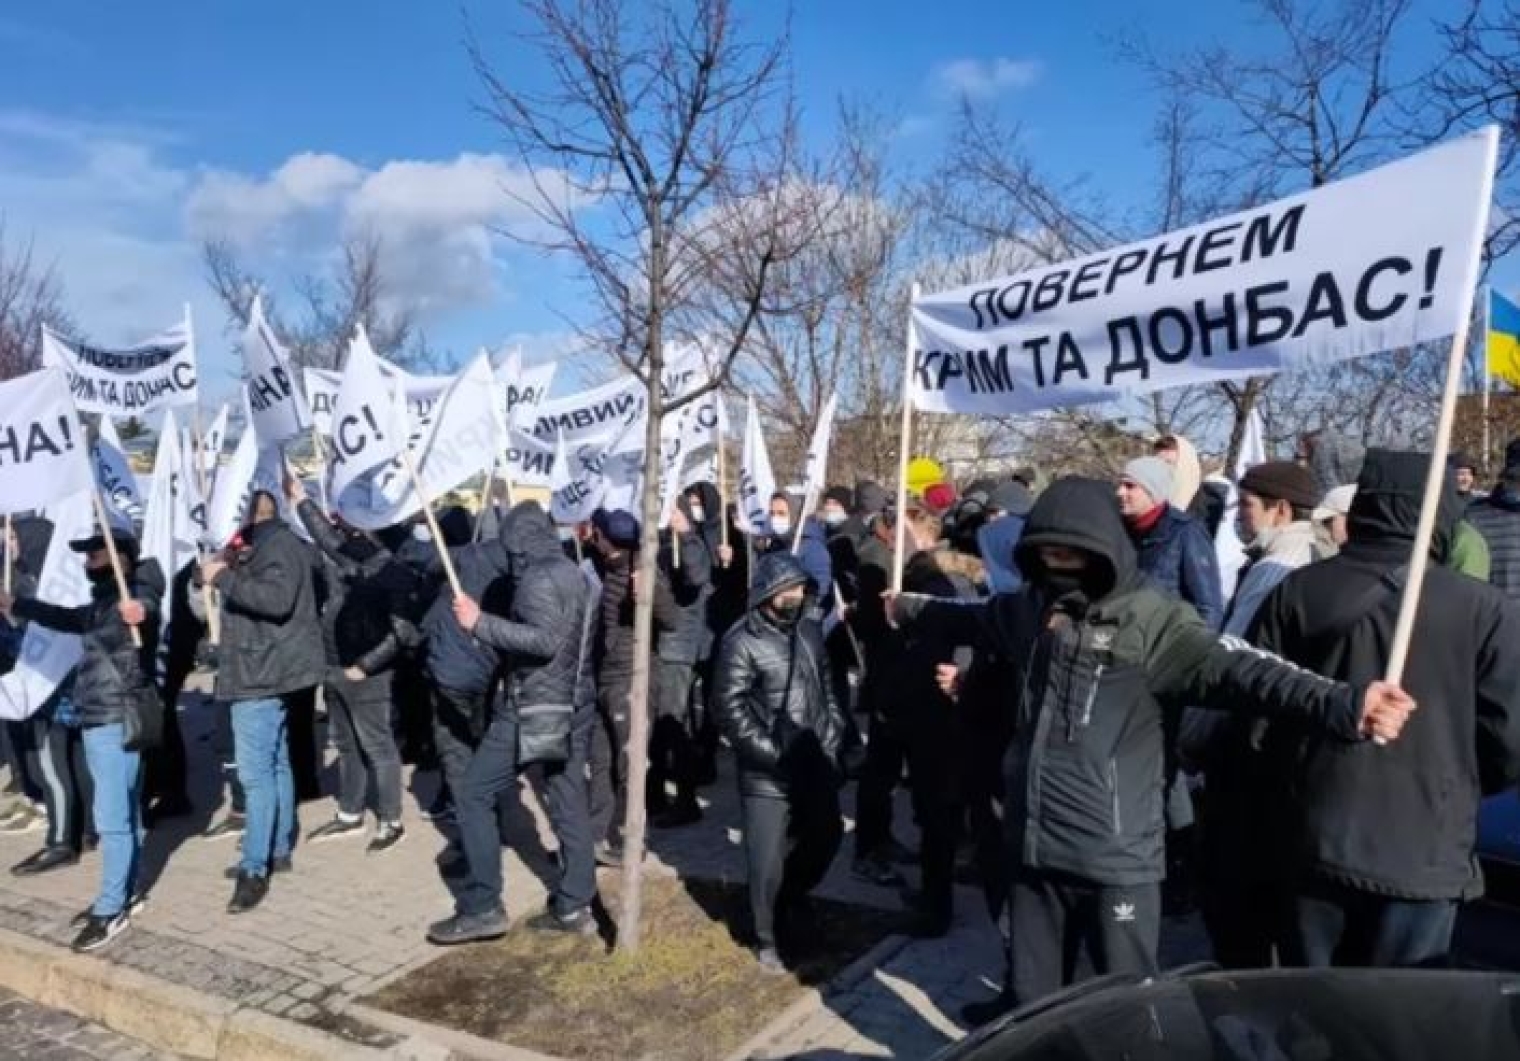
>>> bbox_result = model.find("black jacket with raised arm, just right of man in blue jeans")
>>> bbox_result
[296,500,421,676]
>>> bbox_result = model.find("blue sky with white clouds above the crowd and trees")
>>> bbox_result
[0,0,1471,407]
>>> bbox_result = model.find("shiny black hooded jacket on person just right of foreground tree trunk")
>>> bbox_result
[713,552,845,798]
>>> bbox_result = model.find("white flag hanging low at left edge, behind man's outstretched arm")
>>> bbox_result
[0,486,96,722]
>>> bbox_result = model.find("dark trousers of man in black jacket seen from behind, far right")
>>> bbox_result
[1284,882,1456,968]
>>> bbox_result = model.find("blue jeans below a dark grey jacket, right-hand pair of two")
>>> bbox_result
[233,696,295,877]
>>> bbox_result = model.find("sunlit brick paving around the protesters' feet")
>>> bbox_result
[0,674,1209,1061]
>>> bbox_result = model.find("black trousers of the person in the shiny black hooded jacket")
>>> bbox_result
[742,786,844,947]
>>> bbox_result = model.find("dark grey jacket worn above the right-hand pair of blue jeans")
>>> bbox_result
[211,518,327,701]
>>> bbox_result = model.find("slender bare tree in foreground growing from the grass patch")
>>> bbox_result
[470,0,816,952]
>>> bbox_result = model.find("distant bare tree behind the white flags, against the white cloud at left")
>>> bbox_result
[202,233,436,369]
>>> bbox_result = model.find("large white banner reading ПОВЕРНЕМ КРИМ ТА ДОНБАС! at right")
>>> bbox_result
[910,128,1499,415]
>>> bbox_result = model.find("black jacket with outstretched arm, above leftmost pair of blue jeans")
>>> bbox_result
[15,559,164,727]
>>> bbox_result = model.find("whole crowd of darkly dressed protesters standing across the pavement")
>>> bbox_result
[0,435,1520,1021]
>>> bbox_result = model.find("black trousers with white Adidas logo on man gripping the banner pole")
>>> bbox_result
[1009,869,1161,1006]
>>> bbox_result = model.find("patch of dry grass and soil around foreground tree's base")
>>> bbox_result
[365,877,903,1061]
